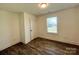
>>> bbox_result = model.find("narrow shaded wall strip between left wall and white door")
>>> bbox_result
[19,13,25,43]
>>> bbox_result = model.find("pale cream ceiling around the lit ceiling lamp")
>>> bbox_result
[0,3,79,15]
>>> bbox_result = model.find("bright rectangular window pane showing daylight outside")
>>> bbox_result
[47,17,57,33]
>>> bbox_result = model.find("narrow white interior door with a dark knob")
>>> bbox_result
[24,14,31,43]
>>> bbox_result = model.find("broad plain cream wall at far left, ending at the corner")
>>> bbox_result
[0,10,20,50]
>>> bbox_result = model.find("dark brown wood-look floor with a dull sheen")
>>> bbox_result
[0,38,79,55]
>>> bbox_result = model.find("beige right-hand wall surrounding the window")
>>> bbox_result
[38,7,79,45]
